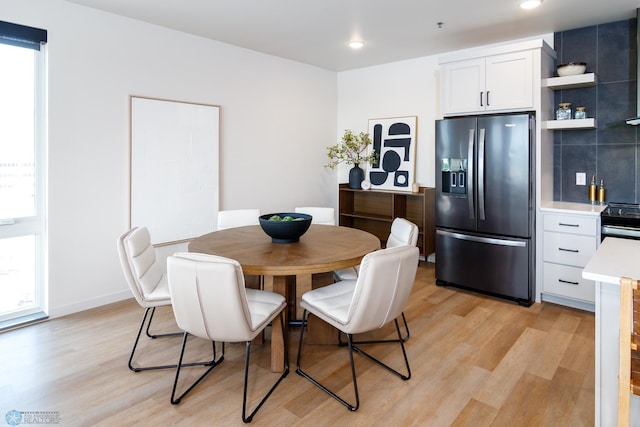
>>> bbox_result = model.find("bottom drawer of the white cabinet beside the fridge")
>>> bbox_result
[543,262,596,303]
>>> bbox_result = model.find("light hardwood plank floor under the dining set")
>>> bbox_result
[0,262,594,426]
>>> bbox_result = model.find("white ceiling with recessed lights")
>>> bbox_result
[67,0,640,71]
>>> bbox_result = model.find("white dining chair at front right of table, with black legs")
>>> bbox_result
[296,246,419,411]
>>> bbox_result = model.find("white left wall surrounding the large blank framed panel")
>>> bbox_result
[0,0,337,317]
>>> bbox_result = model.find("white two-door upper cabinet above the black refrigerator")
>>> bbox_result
[441,50,534,116]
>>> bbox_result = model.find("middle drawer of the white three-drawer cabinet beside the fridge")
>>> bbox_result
[543,231,598,267]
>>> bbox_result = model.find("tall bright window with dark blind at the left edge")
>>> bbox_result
[0,21,47,329]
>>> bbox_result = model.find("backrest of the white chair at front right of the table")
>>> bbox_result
[343,246,419,334]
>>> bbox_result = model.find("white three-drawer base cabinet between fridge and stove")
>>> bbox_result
[542,212,600,311]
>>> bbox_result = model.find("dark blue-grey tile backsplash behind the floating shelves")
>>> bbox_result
[553,18,640,203]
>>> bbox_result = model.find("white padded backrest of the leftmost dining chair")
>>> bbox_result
[118,227,169,307]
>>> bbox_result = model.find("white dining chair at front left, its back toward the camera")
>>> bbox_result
[167,253,289,423]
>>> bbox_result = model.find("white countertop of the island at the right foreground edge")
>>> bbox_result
[582,237,640,283]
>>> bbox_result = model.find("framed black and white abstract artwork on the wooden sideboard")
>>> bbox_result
[366,116,418,191]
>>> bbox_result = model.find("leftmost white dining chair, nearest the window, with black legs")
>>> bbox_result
[118,227,215,372]
